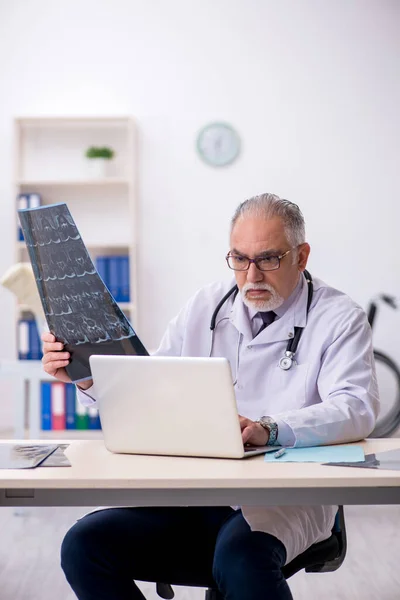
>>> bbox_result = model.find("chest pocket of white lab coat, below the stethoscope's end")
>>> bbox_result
[268,363,309,412]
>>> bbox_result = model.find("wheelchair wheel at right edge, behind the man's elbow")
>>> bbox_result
[369,350,400,438]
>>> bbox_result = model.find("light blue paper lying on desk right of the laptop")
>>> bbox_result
[264,445,365,463]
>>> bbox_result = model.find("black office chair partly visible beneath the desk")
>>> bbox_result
[157,506,347,600]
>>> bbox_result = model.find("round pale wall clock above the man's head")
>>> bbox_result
[197,123,240,167]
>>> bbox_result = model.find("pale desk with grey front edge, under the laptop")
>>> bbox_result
[0,439,400,506]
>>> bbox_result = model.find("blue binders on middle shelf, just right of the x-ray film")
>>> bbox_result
[96,256,130,302]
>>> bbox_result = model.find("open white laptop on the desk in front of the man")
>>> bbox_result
[89,355,277,458]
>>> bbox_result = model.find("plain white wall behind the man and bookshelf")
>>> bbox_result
[0,0,400,432]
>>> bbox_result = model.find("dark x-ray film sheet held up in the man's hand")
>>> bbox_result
[18,204,148,382]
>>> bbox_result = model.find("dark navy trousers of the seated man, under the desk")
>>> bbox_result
[61,507,292,600]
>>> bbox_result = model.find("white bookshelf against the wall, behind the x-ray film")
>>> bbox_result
[12,116,139,439]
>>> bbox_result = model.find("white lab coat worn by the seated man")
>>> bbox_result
[77,277,379,562]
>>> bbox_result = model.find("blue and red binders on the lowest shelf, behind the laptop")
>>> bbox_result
[41,381,101,431]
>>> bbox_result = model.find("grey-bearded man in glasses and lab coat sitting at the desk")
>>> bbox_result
[43,194,379,600]
